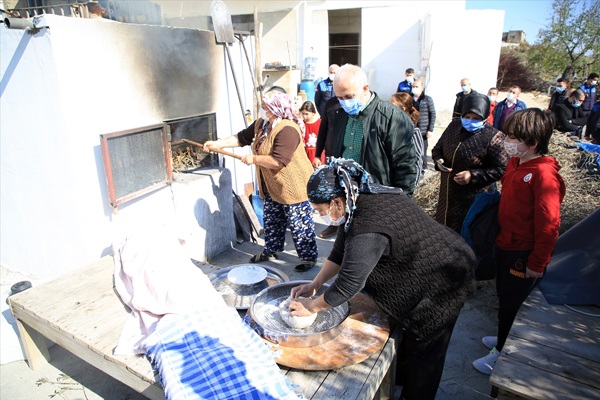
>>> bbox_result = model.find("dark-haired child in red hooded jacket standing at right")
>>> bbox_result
[473,108,565,375]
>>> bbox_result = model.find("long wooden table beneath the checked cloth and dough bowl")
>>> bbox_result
[8,256,398,400]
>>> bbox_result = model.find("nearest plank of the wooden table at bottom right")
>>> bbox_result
[490,356,600,400]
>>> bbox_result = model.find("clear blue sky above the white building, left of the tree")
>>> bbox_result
[466,0,552,44]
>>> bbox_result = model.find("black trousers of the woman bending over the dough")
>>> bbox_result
[396,315,458,400]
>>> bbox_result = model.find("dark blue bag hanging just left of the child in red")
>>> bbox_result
[461,191,500,281]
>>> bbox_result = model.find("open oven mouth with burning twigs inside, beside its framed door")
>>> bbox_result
[166,113,219,172]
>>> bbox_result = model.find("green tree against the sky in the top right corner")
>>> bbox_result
[529,0,600,79]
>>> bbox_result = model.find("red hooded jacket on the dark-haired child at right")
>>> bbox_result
[496,156,566,272]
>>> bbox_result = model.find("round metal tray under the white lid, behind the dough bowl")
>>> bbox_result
[208,264,290,310]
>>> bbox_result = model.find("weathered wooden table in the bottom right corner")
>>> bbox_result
[490,289,600,400]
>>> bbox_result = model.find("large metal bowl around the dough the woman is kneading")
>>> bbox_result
[250,281,350,347]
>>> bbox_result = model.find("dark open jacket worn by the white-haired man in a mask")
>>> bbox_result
[331,93,422,195]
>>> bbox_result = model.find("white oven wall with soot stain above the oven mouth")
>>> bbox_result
[0,16,244,279]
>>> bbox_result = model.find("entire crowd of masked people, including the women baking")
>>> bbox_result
[204,64,600,399]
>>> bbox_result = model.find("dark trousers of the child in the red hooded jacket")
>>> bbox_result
[494,248,540,351]
